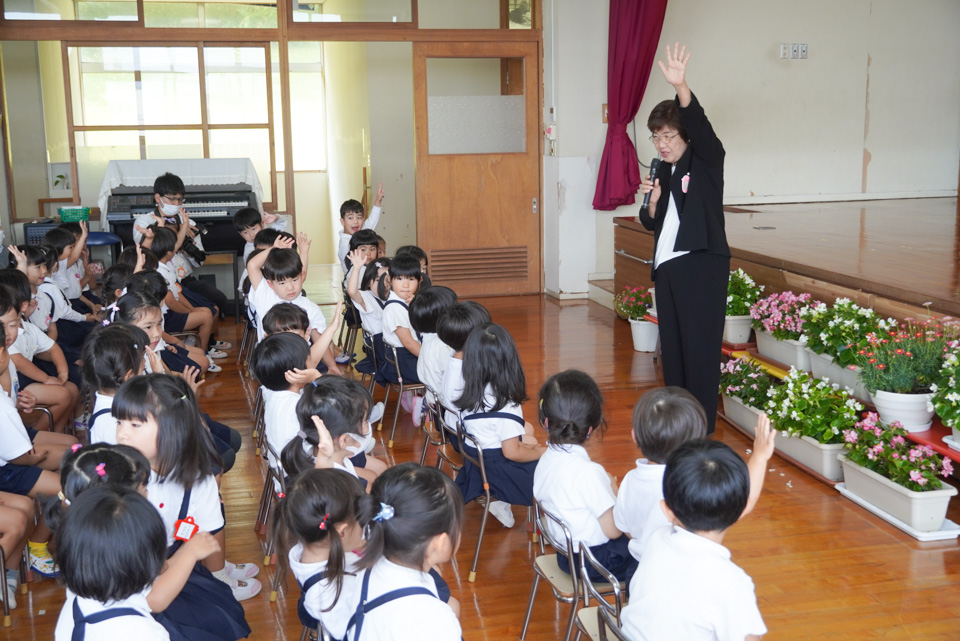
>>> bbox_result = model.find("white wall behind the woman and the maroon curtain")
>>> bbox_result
[544,0,960,293]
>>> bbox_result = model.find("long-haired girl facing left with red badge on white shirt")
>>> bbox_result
[112,374,260,601]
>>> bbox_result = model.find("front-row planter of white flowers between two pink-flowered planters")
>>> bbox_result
[764,369,863,481]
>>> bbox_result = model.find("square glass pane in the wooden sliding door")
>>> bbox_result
[427,58,526,154]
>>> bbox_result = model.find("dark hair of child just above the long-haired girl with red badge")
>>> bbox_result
[80,324,150,392]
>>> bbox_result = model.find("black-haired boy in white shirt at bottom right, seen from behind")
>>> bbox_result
[621,439,767,641]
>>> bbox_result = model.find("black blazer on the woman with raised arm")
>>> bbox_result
[638,96,730,280]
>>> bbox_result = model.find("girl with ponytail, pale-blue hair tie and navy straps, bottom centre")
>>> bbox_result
[347,463,463,641]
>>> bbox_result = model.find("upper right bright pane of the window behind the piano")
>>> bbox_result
[203,47,268,125]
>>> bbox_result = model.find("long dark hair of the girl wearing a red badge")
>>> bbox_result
[111,374,223,490]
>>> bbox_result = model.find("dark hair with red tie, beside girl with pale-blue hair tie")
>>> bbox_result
[273,469,374,612]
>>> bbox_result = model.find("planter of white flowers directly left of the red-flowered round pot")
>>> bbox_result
[800,298,896,401]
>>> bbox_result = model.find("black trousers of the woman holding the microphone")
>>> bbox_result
[654,252,730,434]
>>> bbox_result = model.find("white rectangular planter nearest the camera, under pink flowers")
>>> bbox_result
[838,454,957,532]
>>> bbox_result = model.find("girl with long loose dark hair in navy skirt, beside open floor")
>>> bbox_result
[452,323,546,527]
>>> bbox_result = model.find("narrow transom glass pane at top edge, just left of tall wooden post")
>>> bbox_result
[143,0,277,29]
